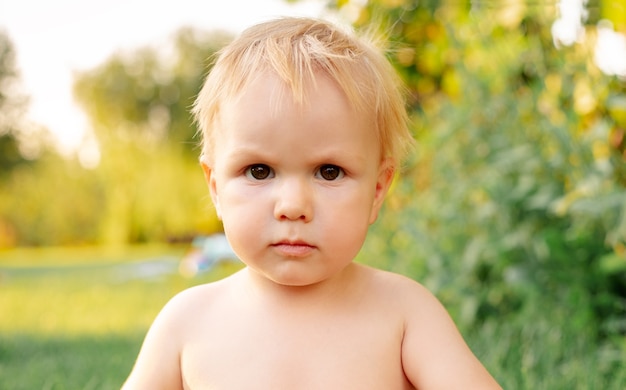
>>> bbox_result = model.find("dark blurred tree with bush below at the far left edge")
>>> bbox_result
[0,32,98,248]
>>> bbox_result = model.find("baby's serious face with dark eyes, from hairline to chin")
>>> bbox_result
[208,75,392,286]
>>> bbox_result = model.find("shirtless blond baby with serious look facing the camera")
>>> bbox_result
[124,18,500,390]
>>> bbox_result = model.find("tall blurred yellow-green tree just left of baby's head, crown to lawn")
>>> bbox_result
[74,29,229,244]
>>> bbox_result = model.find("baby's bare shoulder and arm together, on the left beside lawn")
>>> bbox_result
[123,272,236,389]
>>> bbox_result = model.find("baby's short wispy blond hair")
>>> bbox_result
[192,17,413,166]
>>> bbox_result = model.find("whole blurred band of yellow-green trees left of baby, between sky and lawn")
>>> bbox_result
[0,29,228,248]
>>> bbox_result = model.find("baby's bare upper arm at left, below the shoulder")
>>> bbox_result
[122,290,185,390]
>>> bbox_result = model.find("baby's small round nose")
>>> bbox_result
[274,178,313,222]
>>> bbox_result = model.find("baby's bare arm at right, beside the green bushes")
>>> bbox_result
[402,284,501,390]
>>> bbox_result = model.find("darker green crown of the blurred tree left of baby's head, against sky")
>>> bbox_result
[74,29,229,160]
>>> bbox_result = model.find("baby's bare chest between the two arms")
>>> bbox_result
[181,310,411,390]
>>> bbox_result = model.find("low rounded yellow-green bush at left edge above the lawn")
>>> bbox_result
[0,152,102,247]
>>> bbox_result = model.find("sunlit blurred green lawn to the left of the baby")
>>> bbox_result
[0,247,239,390]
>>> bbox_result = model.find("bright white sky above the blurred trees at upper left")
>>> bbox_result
[0,0,336,153]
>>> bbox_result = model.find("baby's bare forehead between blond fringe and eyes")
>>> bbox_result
[211,70,381,165]
